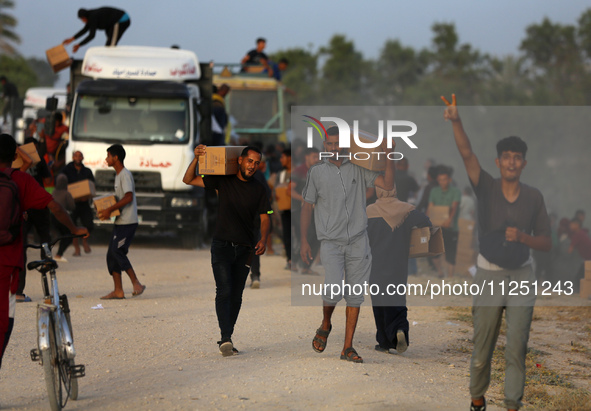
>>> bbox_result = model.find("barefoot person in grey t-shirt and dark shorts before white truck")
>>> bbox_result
[99,144,146,300]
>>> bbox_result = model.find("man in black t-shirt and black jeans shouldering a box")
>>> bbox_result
[183,144,272,357]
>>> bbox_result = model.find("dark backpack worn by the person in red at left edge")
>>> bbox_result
[0,169,21,246]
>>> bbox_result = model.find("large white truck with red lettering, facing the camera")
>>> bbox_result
[66,46,212,248]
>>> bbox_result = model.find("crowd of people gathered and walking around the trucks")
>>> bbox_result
[0,18,591,411]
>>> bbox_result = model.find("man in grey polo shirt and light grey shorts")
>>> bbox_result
[300,126,394,363]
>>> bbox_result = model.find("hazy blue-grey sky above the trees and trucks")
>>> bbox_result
[10,0,591,85]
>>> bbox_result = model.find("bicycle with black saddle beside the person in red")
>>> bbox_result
[26,236,86,411]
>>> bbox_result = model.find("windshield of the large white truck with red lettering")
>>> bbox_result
[71,95,189,144]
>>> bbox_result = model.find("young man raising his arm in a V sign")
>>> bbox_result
[441,94,552,411]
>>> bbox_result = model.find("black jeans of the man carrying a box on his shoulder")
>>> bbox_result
[211,239,254,342]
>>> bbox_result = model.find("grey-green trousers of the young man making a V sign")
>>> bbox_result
[470,265,536,409]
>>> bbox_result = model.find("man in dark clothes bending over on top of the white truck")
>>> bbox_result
[62,7,131,53]
